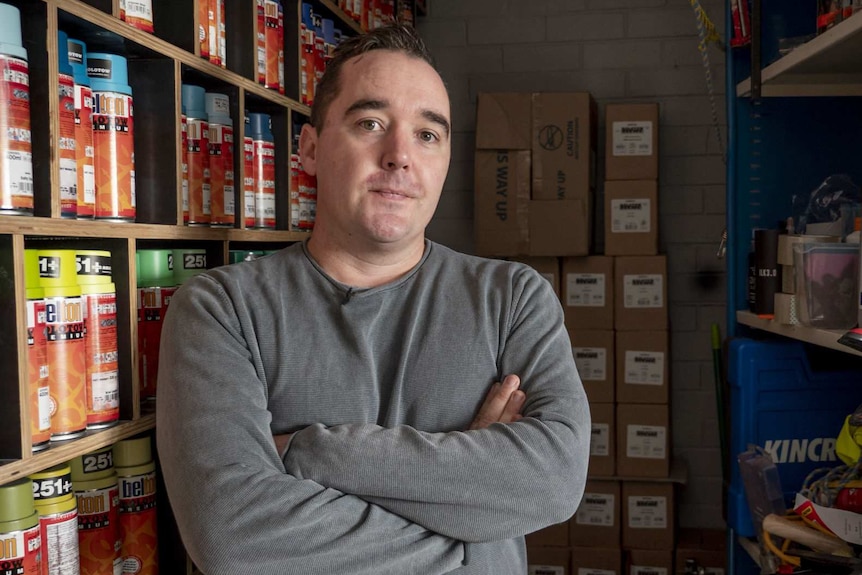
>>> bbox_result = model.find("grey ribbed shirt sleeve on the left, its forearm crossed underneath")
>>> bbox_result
[156,276,465,575]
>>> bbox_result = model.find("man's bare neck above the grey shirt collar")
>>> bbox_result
[308,234,425,288]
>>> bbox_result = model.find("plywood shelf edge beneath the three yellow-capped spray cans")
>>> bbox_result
[0,414,156,485]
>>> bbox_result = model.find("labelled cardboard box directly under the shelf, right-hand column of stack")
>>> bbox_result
[623,481,676,552]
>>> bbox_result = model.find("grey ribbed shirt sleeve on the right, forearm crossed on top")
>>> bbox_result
[284,270,590,542]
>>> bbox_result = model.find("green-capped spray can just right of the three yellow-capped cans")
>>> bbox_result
[137,249,176,401]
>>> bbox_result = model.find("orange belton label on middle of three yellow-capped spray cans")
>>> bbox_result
[44,294,87,439]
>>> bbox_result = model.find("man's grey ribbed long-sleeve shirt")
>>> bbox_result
[156,242,590,575]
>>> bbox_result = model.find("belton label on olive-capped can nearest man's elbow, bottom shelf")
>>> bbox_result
[119,472,159,575]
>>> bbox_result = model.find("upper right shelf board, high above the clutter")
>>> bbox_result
[736,14,862,96]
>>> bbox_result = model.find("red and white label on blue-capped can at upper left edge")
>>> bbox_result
[0,55,33,213]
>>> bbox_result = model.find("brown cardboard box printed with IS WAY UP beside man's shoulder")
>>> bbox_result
[473,150,530,256]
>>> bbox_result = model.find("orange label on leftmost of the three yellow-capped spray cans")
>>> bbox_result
[27,299,51,449]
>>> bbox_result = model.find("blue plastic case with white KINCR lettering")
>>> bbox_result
[727,338,862,537]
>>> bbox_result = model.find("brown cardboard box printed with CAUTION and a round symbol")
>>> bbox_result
[532,92,598,202]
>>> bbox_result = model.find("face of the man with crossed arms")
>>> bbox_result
[301,50,450,253]
